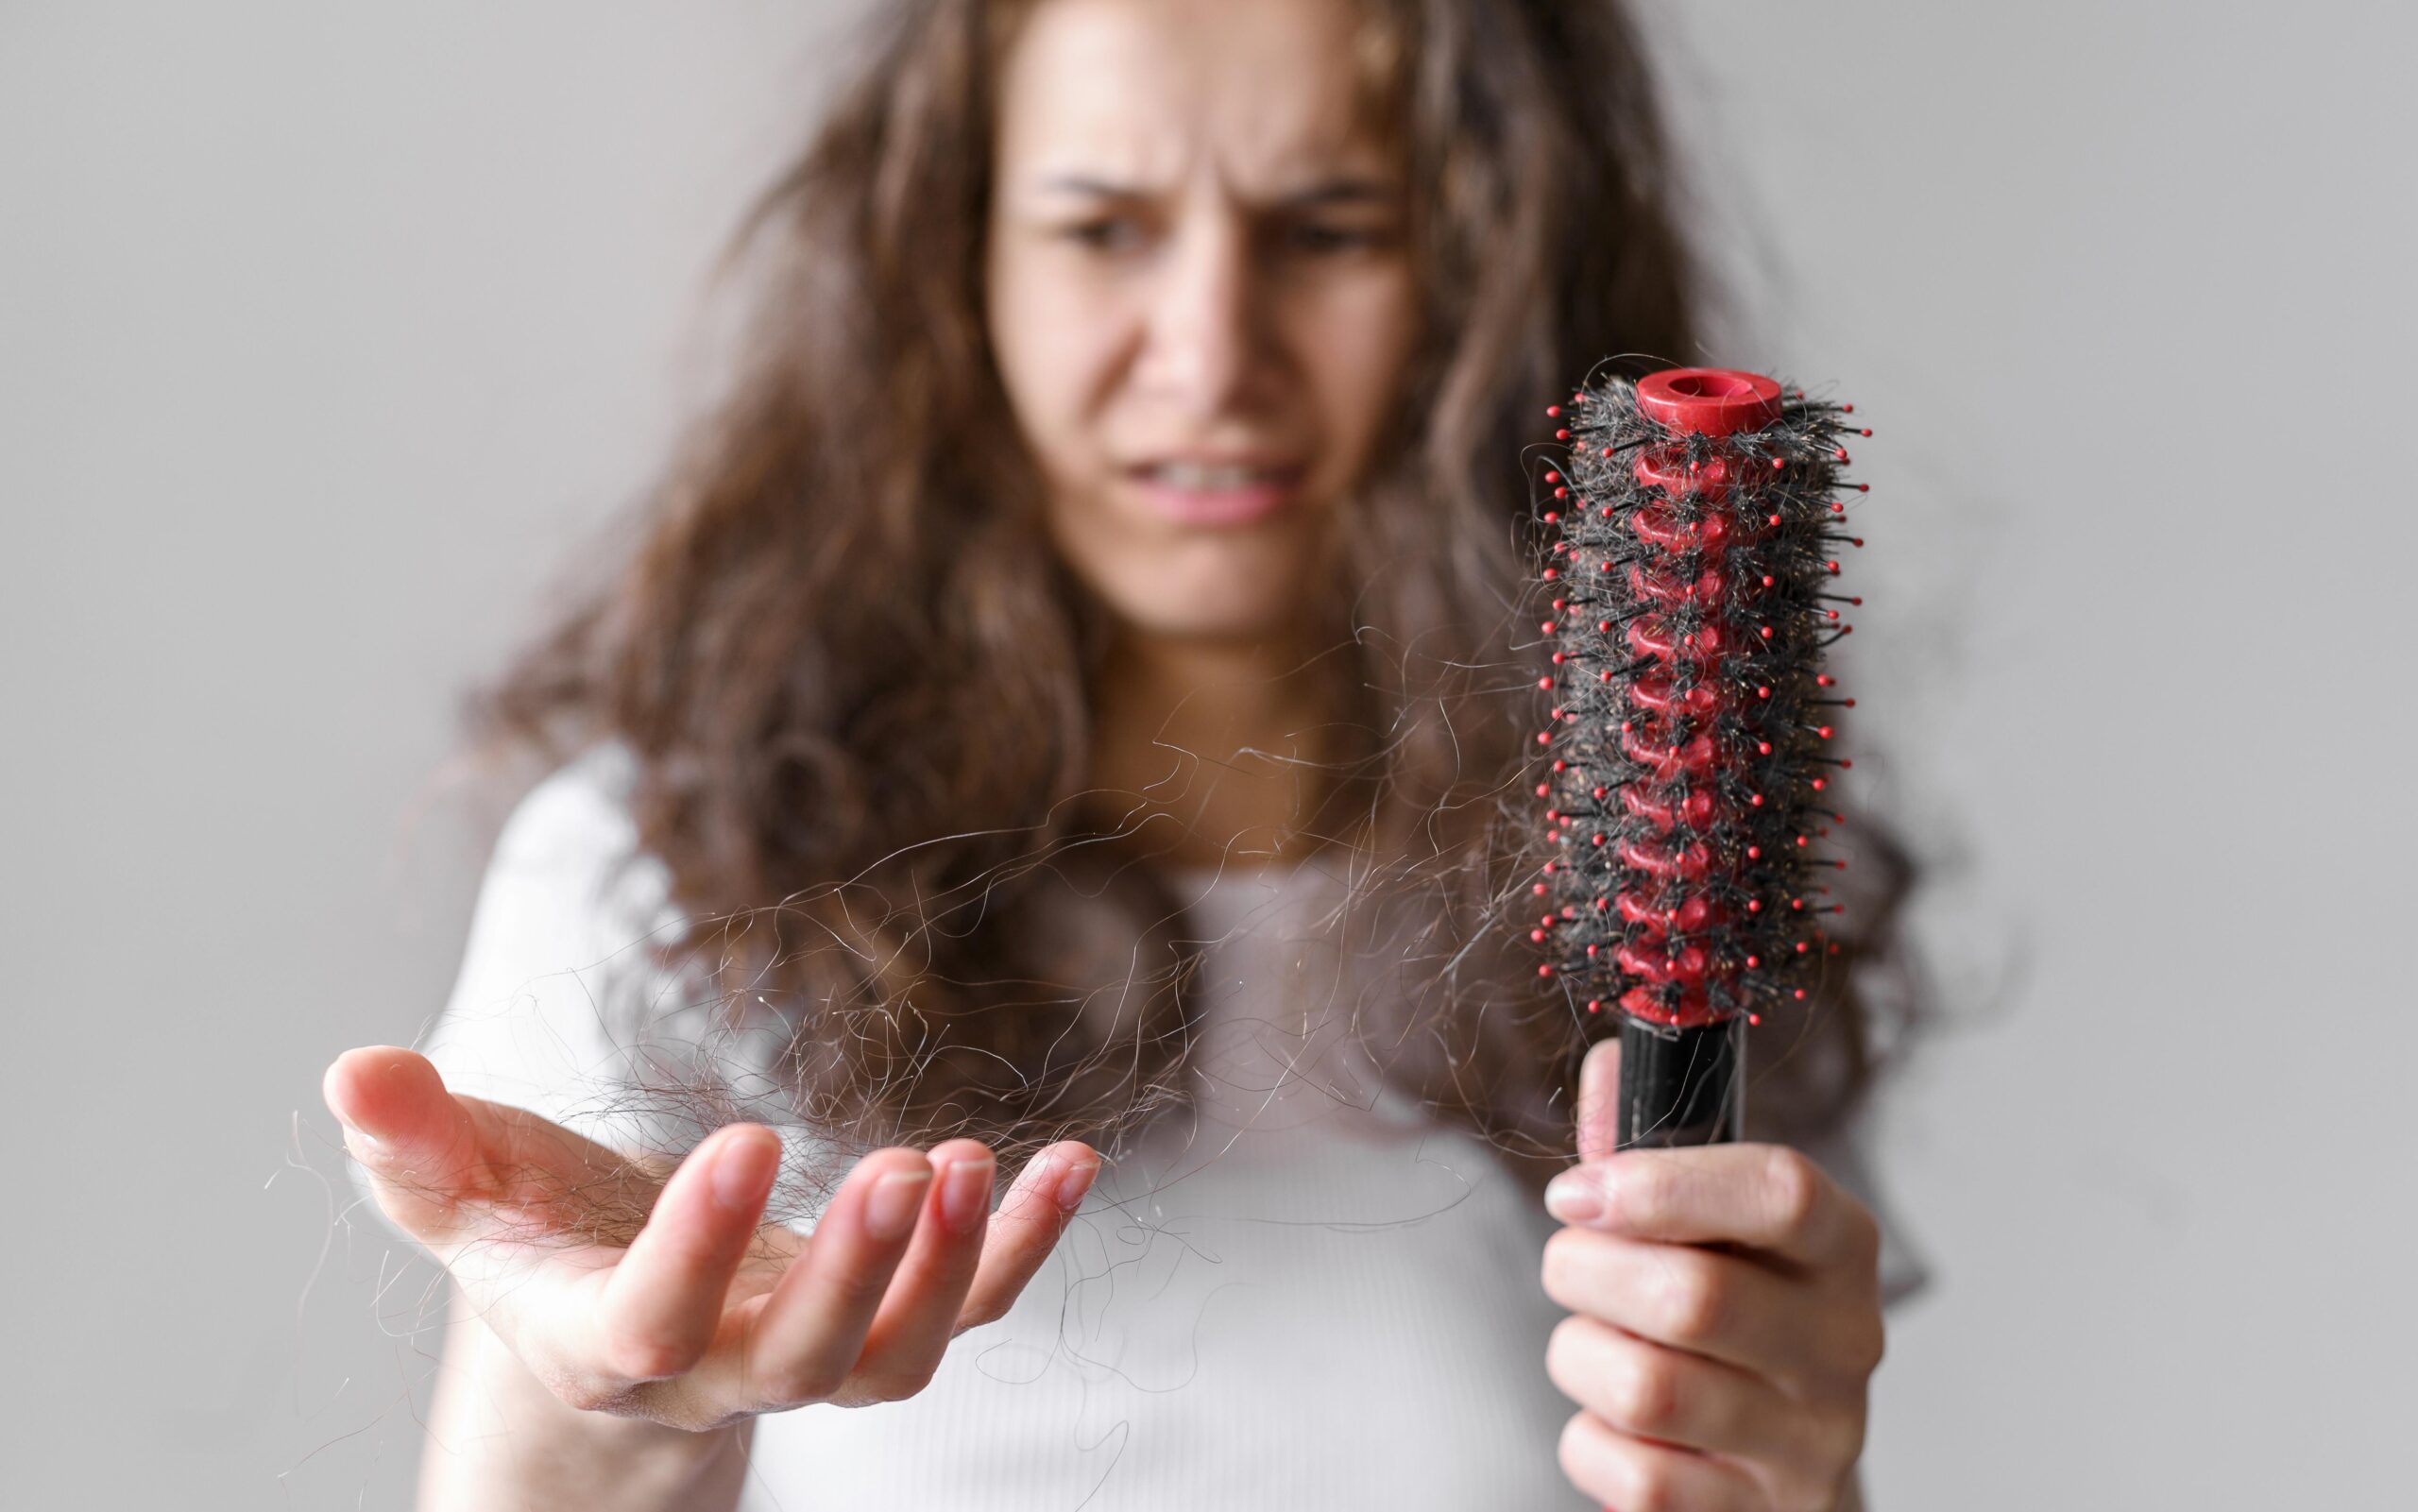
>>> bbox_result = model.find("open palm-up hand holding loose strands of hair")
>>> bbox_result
[324,1047,1100,1432]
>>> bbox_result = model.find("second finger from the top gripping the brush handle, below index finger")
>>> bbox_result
[1545,1229,1818,1377]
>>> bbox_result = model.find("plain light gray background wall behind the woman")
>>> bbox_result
[0,0,2418,1512]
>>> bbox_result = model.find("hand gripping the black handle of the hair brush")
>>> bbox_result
[1545,1040,1882,1512]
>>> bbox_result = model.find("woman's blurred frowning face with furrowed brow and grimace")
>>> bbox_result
[986,0,1417,638]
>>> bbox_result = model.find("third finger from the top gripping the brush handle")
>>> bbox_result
[1545,1317,1795,1459]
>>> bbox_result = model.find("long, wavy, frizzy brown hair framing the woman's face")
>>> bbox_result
[474,0,1910,1195]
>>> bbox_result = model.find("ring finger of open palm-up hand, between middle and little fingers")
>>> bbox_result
[856,1140,996,1401]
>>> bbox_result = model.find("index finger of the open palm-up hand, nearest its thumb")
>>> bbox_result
[595,1123,781,1382]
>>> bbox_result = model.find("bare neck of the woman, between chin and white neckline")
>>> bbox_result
[1093,634,1335,869]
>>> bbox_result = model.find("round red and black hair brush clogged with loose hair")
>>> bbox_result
[1530,367,1871,1149]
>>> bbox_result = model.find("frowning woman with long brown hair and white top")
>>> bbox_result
[327,0,1915,1509]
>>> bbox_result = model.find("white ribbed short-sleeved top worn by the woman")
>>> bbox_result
[423,748,1917,1512]
